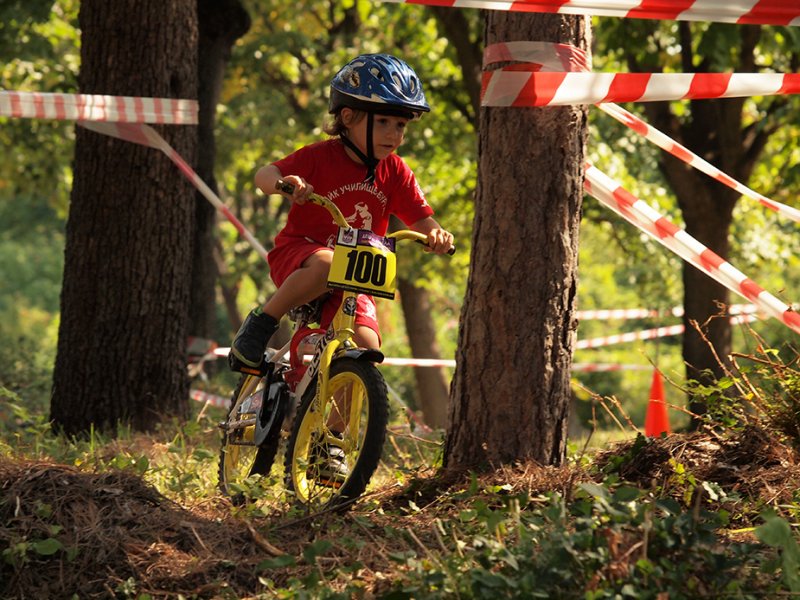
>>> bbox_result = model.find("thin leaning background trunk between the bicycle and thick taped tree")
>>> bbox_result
[397,279,450,428]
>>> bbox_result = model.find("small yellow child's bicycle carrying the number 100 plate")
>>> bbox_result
[219,181,455,511]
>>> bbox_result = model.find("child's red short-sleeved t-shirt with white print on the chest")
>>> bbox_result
[274,139,433,250]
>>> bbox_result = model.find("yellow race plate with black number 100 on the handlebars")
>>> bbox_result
[328,228,397,299]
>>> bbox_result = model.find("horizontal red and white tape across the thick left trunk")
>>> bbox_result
[0,91,197,125]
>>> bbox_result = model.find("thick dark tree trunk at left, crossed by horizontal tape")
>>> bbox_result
[51,0,197,434]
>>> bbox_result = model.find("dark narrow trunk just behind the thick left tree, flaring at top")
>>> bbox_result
[189,0,250,338]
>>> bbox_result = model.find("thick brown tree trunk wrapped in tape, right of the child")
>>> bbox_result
[445,12,590,468]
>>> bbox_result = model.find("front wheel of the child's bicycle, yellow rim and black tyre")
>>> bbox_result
[285,358,389,511]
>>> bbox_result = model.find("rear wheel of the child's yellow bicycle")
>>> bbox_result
[219,375,287,505]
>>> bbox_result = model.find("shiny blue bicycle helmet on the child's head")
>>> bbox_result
[329,54,430,119]
